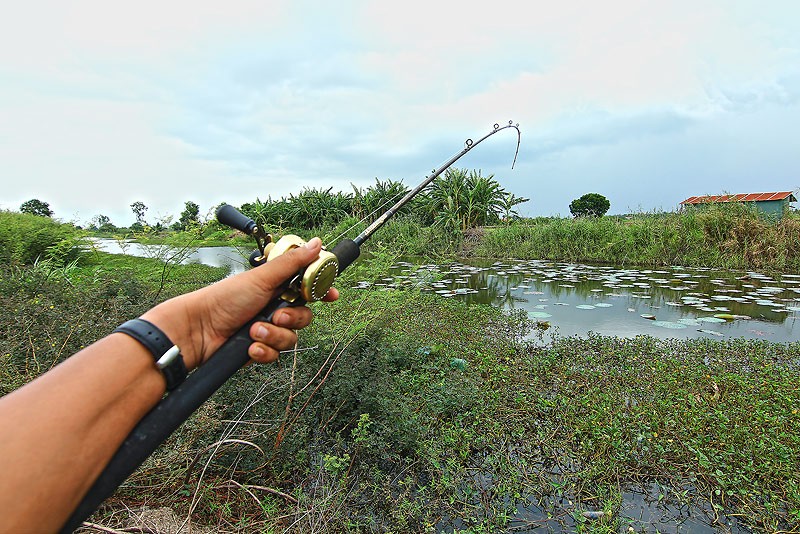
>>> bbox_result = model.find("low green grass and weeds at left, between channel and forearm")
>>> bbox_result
[0,252,226,394]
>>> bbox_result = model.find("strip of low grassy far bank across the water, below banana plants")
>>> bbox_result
[78,204,800,272]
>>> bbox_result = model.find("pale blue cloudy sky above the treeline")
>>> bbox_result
[0,0,800,226]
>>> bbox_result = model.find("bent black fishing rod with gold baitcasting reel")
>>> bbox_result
[59,121,521,534]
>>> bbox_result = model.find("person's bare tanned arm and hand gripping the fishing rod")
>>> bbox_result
[0,239,338,532]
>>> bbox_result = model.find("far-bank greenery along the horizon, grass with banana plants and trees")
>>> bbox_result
[73,173,800,271]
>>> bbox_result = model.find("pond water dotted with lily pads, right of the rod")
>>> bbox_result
[370,258,800,342]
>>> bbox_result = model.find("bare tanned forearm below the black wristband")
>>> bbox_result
[0,334,165,532]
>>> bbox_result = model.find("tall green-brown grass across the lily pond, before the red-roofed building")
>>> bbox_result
[473,204,800,271]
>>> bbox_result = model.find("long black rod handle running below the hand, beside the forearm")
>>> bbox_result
[59,299,305,534]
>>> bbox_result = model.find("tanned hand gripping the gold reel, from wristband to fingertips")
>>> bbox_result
[142,237,339,370]
